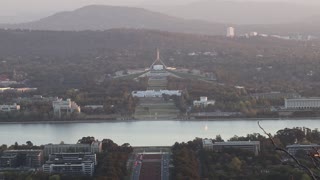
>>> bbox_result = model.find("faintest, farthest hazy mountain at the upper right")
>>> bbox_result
[148,0,320,24]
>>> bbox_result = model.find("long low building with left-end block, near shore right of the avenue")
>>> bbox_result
[202,139,260,156]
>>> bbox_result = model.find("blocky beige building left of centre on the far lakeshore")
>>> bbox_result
[52,99,81,117]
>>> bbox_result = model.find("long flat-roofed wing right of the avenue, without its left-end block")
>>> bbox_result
[212,141,260,156]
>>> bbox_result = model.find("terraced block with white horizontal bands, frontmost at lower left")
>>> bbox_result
[43,153,97,176]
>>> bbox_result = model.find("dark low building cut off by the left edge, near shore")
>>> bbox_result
[0,150,43,168]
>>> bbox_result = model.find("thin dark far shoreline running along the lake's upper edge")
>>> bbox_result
[0,117,320,125]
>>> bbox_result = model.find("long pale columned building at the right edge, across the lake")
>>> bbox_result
[284,97,320,109]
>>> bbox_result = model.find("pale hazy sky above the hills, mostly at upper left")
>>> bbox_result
[0,0,320,23]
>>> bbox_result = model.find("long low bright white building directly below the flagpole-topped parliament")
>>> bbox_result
[132,90,181,98]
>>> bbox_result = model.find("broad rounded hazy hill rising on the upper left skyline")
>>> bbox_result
[0,5,226,35]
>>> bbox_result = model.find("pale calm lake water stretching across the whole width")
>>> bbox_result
[0,119,320,146]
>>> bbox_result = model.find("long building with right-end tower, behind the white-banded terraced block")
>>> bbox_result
[43,141,102,157]
